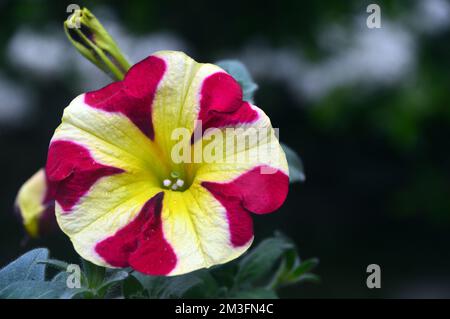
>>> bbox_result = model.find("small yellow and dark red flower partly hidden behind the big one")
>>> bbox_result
[15,169,57,238]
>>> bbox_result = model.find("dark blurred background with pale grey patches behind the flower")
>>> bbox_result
[0,0,450,298]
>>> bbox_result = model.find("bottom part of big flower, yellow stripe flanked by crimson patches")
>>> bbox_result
[91,185,253,275]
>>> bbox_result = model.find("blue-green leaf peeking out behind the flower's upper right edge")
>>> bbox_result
[216,60,258,103]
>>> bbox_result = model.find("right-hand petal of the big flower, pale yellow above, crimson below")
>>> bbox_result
[192,106,289,247]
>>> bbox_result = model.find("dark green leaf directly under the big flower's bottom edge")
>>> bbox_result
[132,271,201,299]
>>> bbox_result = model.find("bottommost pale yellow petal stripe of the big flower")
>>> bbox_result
[158,184,253,275]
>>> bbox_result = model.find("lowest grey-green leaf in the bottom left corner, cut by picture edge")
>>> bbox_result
[0,280,67,299]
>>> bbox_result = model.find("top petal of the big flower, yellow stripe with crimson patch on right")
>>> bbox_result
[152,51,257,159]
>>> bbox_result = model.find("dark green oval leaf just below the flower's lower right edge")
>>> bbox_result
[236,237,292,285]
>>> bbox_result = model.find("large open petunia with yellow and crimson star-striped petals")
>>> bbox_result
[46,51,289,275]
